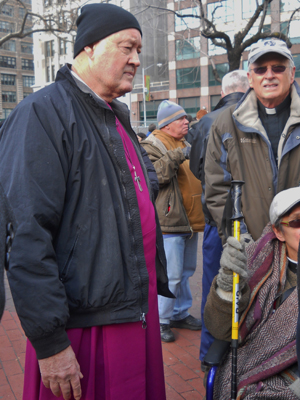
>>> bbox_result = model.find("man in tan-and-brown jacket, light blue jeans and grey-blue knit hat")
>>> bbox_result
[141,100,205,342]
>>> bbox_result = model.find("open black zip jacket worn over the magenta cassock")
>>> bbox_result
[0,66,172,358]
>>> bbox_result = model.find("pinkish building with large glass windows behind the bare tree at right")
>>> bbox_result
[131,0,300,129]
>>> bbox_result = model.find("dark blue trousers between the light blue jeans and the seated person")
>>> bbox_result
[200,224,223,361]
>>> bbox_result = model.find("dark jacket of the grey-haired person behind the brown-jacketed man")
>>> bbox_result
[190,92,244,226]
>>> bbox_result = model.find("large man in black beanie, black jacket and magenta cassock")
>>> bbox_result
[0,3,173,400]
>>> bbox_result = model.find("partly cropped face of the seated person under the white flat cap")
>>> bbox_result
[273,205,300,261]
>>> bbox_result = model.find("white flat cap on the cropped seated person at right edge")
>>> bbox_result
[269,186,300,224]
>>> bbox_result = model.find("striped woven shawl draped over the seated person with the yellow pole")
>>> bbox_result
[214,224,298,400]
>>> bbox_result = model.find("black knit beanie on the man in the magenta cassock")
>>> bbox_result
[74,3,142,58]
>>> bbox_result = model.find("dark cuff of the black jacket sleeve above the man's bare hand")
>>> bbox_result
[28,327,71,360]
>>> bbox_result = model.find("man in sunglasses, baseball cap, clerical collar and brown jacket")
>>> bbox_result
[205,38,300,248]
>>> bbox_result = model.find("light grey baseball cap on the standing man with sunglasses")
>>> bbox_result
[248,39,294,65]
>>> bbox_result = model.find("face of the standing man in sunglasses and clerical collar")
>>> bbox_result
[248,53,295,108]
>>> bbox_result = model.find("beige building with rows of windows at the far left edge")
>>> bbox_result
[0,0,35,121]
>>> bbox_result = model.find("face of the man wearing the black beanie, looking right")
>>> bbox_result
[85,29,142,100]
